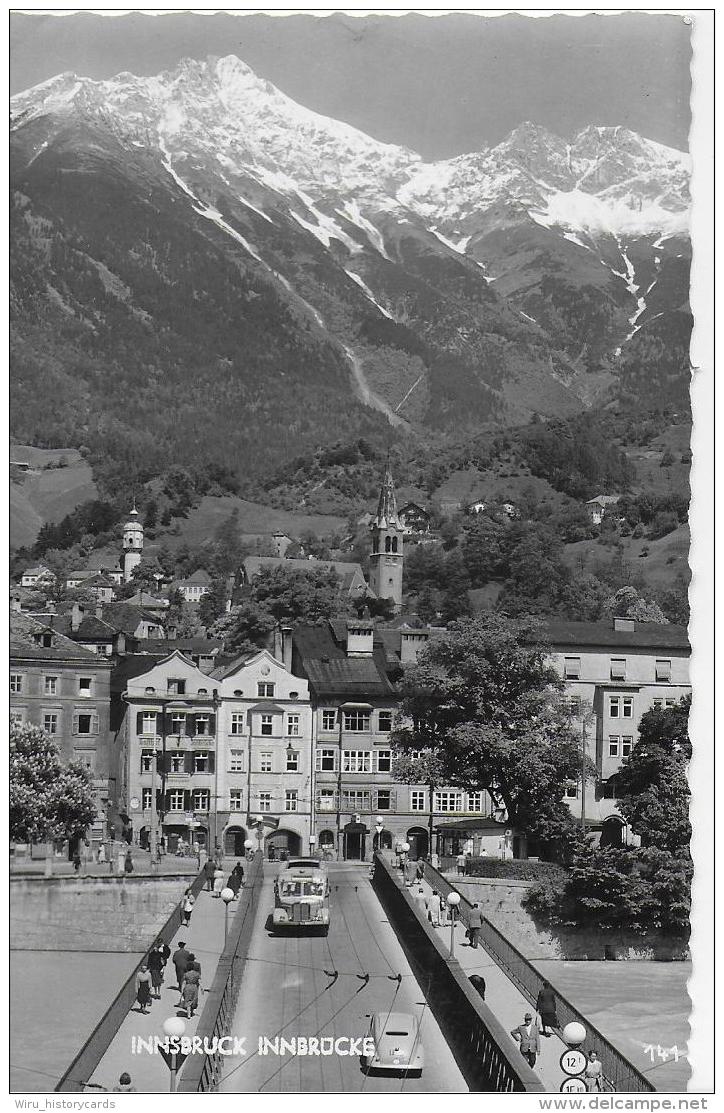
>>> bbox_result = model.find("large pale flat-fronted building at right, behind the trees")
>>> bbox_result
[540,618,692,844]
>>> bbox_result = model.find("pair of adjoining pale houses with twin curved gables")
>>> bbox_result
[117,650,313,855]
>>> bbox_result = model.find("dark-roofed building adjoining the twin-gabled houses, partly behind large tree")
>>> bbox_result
[292,619,502,860]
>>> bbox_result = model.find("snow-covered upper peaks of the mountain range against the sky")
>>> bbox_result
[12,55,688,242]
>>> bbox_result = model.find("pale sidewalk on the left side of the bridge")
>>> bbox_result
[89,892,237,1094]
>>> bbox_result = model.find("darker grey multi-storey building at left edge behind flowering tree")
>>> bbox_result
[10,610,117,853]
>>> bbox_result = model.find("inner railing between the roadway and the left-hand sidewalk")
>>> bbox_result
[178,851,264,1094]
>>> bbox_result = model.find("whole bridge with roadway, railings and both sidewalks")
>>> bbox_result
[56,855,654,1094]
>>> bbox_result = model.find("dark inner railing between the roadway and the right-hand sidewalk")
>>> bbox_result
[372,855,545,1094]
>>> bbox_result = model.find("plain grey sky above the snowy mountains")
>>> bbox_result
[10,12,691,159]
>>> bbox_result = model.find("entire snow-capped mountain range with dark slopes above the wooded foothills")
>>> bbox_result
[11,56,689,496]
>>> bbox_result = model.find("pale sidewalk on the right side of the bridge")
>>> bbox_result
[408,881,566,1093]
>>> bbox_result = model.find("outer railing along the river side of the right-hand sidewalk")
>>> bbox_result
[424,863,656,1094]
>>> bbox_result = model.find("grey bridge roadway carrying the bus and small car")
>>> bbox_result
[219,863,468,1093]
